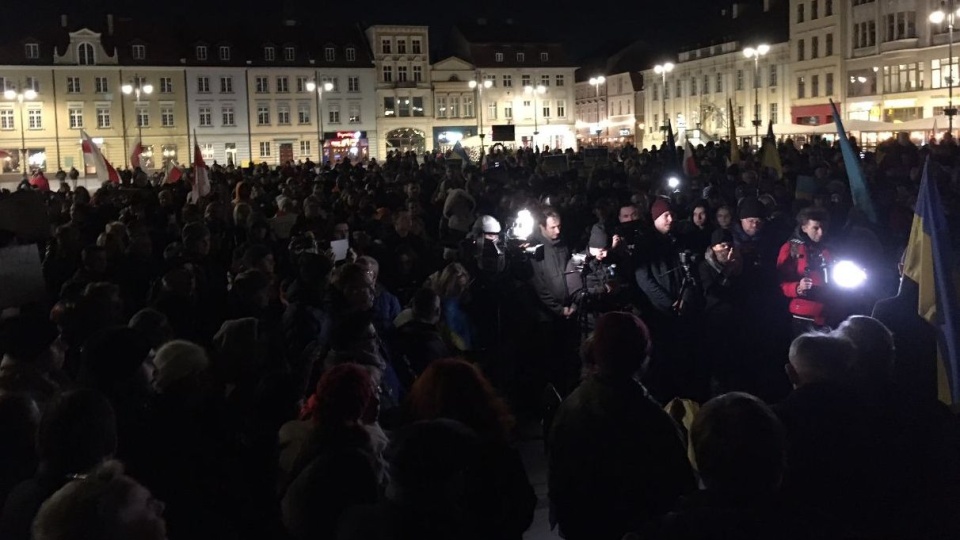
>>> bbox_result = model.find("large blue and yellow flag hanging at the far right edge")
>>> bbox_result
[903,158,960,405]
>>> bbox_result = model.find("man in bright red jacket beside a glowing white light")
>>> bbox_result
[777,207,833,333]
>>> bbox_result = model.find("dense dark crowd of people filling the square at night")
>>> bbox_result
[0,132,960,540]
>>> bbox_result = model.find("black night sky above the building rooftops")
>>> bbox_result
[20,0,721,59]
